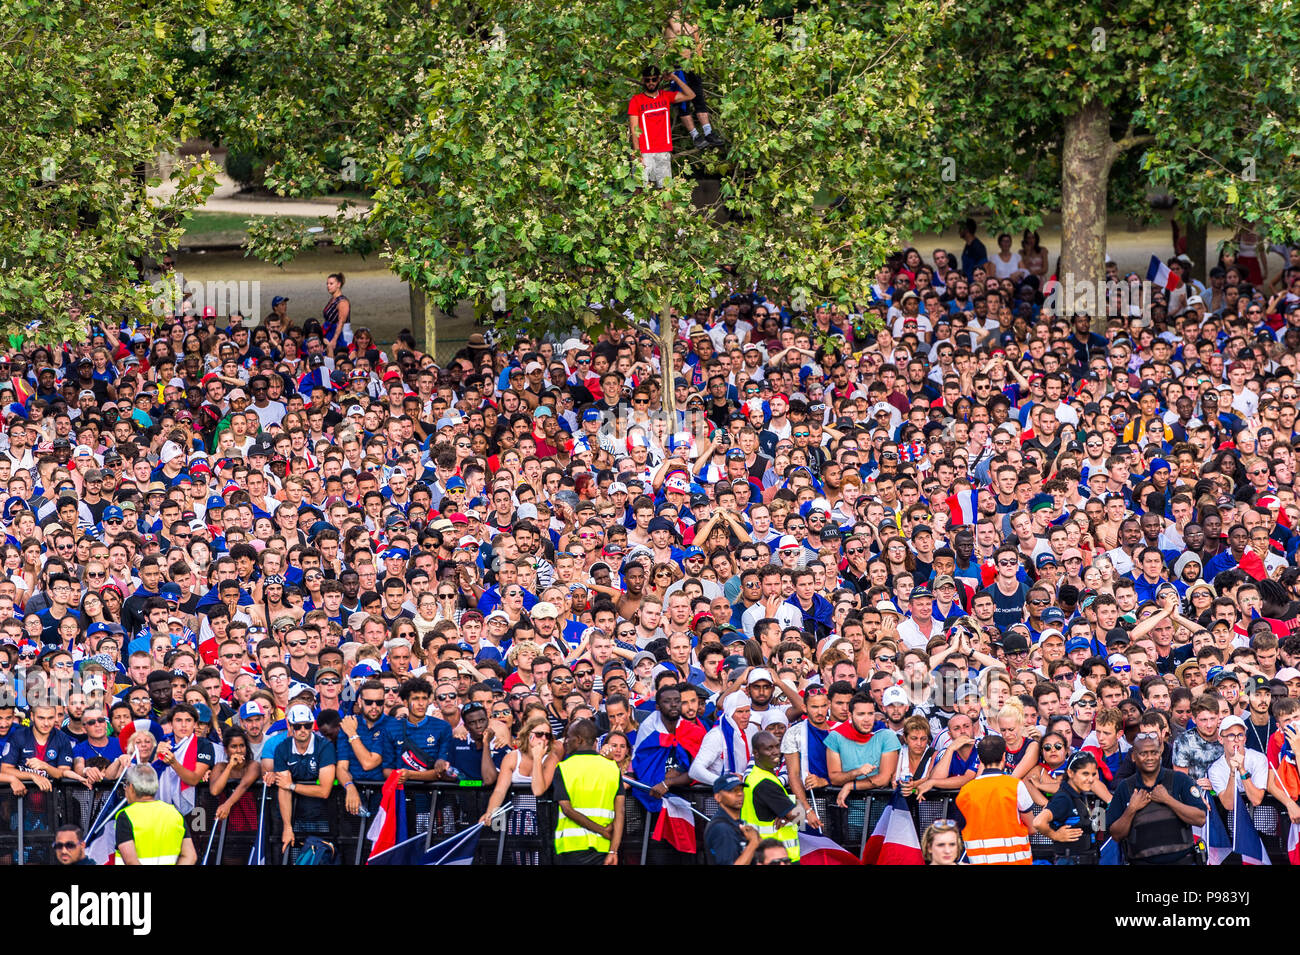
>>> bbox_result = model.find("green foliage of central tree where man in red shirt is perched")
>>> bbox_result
[369,0,946,407]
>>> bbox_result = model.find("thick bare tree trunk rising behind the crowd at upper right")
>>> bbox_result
[1057,103,1118,331]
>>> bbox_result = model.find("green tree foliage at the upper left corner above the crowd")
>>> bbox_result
[0,0,212,342]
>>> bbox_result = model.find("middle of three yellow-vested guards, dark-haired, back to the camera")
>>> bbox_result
[553,720,627,865]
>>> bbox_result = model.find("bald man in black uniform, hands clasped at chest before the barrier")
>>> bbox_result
[1106,733,1206,865]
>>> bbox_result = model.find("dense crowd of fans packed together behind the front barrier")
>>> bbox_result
[0,223,1300,864]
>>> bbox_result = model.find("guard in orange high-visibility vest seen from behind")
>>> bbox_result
[956,735,1034,865]
